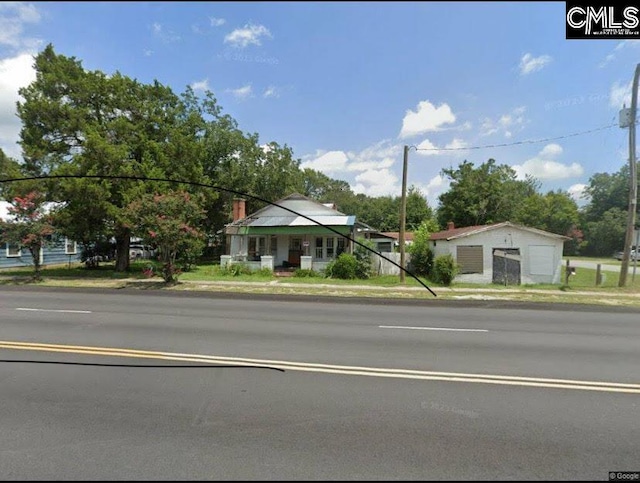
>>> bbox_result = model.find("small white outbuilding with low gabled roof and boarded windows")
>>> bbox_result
[429,221,570,285]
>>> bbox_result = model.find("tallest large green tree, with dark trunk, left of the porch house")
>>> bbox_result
[18,45,203,271]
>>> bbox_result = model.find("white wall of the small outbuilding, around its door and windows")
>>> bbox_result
[430,227,564,284]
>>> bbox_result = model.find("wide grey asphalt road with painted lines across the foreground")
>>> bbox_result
[0,288,640,480]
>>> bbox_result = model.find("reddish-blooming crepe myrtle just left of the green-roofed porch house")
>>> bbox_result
[125,191,205,284]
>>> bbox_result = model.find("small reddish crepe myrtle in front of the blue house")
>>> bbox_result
[0,191,54,281]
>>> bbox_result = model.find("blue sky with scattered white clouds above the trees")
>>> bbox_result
[0,1,640,207]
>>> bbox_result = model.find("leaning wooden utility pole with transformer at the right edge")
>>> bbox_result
[618,64,640,287]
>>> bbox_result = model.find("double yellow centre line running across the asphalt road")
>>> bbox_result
[0,341,640,394]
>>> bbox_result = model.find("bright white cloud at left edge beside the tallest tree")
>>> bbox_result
[0,54,36,158]
